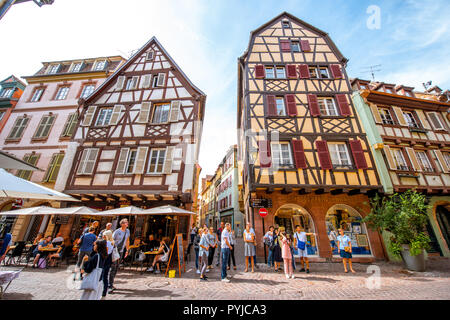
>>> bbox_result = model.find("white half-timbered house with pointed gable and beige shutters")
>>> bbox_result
[58,37,206,240]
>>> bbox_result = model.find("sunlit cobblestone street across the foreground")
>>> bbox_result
[2,240,450,300]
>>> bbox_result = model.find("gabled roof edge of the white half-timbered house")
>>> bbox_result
[79,36,206,104]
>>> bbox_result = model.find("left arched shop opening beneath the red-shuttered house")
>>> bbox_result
[274,204,319,256]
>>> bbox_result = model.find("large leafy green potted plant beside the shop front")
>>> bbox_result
[364,190,430,272]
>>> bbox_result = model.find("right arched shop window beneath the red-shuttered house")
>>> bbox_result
[325,204,372,256]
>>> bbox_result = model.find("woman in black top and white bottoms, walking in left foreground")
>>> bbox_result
[80,240,108,300]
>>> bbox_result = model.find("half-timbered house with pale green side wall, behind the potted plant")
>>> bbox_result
[351,79,450,257]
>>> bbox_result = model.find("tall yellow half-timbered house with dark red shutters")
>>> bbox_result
[237,13,384,261]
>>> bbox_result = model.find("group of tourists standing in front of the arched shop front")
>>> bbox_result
[188,222,355,282]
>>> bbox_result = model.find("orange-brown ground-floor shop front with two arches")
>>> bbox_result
[247,191,386,262]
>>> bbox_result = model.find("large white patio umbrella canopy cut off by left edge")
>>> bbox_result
[0,168,80,201]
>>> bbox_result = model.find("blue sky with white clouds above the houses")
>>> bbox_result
[0,0,450,181]
